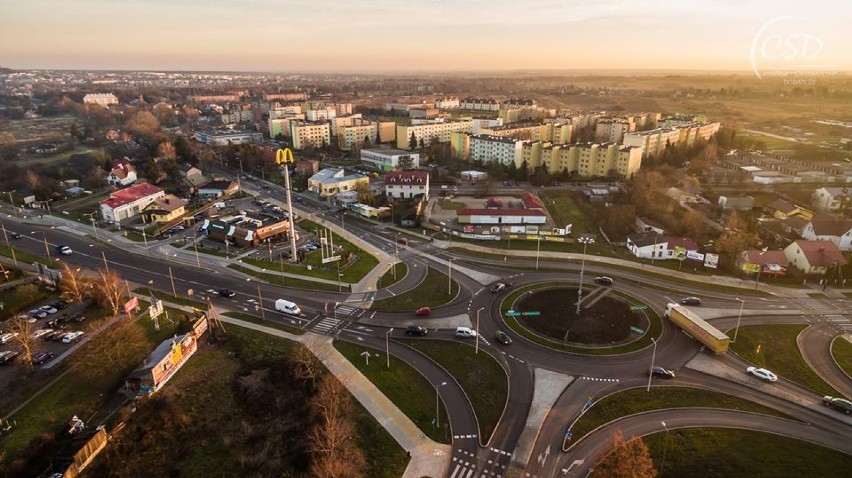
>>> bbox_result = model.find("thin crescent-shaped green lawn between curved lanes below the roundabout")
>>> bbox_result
[571,380,792,442]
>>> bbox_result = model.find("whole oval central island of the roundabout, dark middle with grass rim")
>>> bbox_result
[500,282,662,355]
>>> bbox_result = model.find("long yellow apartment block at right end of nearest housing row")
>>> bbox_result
[518,142,642,178]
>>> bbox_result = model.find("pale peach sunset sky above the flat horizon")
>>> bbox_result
[0,0,852,74]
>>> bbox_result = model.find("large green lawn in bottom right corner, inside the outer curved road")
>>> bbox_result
[645,428,852,478]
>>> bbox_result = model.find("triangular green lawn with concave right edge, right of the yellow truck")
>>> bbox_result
[731,324,841,397]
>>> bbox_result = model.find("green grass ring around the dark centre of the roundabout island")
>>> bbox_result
[500,282,663,355]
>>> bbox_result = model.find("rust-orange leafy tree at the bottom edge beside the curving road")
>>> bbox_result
[592,430,657,478]
